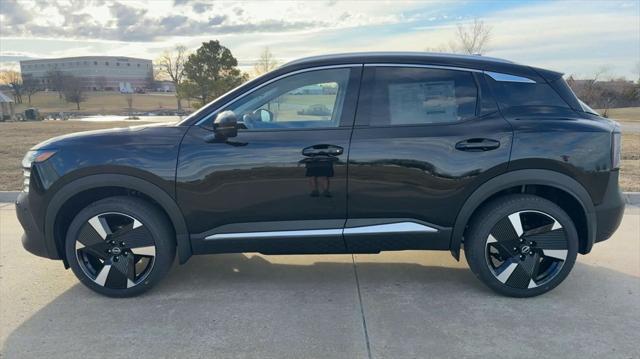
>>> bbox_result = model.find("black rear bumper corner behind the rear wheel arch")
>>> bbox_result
[594,171,625,242]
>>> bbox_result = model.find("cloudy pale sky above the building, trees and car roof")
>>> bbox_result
[0,0,640,79]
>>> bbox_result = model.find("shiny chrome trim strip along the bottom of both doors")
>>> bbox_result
[204,222,438,240]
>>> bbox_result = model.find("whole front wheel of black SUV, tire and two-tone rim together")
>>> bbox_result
[65,197,176,297]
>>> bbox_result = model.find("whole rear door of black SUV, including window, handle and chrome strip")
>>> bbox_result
[344,64,512,252]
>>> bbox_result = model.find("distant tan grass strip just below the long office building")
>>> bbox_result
[16,91,190,115]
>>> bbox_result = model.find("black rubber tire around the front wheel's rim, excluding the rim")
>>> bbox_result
[65,197,175,297]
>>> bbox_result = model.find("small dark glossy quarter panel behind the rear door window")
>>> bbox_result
[485,76,569,109]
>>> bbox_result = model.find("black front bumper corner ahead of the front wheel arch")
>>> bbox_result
[16,192,60,259]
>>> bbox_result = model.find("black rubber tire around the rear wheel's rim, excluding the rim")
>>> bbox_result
[464,195,579,297]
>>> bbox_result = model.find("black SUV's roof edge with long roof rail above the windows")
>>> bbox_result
[279,52,562,81]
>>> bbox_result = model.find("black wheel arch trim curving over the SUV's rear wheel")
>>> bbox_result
[450,169,597,260]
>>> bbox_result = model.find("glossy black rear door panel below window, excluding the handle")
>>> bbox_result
[349,113,512,231]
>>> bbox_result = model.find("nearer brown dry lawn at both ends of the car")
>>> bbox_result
[0,121,640,191]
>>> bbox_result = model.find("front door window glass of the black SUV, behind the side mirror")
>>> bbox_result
[224,68,351,130]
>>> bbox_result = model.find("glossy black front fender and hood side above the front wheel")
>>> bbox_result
[29,126,188,238]
